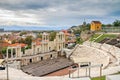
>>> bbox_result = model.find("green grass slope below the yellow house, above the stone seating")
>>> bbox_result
[90,34,117,42]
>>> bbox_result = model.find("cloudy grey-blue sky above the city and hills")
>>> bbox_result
[0,0,120,27]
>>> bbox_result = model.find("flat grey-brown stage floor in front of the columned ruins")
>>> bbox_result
[22,57,73,76]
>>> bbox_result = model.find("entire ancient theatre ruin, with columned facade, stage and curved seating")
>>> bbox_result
[2,32,120,77]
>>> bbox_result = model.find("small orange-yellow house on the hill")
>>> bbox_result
[90,21,102,31]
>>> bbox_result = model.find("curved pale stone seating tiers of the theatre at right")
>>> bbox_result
[68,41,120,77]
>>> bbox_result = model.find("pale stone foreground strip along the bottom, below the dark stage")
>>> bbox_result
[0,68,90,80]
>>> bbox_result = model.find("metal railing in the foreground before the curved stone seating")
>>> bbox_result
[69,62,103,80]
